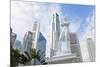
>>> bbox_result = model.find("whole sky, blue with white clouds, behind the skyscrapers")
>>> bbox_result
[11,1,95,60]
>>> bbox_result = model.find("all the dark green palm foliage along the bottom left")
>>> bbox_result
[11,48,46,66]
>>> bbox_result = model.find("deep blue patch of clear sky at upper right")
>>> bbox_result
[61,4,95,33]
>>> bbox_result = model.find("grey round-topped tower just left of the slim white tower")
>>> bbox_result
[23,31,33,52]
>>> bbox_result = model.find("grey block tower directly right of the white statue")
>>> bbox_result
[70,33,82,62]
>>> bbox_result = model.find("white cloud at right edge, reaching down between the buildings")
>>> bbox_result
[79,13,95,61]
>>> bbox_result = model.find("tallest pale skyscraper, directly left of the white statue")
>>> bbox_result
[50,13,60,57]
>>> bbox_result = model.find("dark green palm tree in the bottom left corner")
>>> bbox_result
[11,48,31,66]
